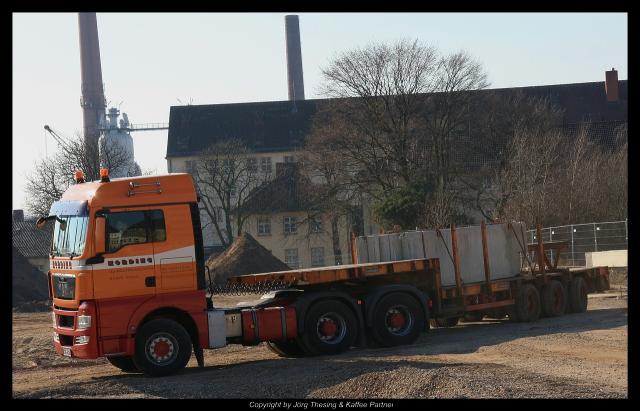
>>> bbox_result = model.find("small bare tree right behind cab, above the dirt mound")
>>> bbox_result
[190,139,266,247]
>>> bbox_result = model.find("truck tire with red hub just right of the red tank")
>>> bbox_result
[300,300,359,355]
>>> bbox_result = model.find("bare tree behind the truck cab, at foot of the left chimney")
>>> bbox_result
[25,135,130,216]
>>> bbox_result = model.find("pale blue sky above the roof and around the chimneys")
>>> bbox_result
[12,11,627,212]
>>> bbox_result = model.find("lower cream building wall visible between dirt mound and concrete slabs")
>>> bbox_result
[245,212,351,268]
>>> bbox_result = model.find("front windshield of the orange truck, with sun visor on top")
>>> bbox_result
[49,201,89,257]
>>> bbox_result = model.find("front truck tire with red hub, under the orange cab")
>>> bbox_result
[133,318,192,377]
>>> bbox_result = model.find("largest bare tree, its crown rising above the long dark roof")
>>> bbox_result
[312,40,488,232]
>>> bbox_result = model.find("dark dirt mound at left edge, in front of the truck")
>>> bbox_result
[11,247,49,307]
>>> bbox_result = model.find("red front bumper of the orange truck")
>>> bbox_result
[53,301,98,359]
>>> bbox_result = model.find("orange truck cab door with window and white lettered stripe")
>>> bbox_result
[94,209,157,298]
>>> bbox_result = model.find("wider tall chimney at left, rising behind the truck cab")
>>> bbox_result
[78,13,106,171]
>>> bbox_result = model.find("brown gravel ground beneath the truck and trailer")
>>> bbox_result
[13,287,627,399]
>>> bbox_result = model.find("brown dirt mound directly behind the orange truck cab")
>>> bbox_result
[207,233,291,285]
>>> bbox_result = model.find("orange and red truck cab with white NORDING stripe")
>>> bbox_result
[47,172,208,376]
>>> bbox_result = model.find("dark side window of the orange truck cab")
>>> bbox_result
[105,210,167,253]
